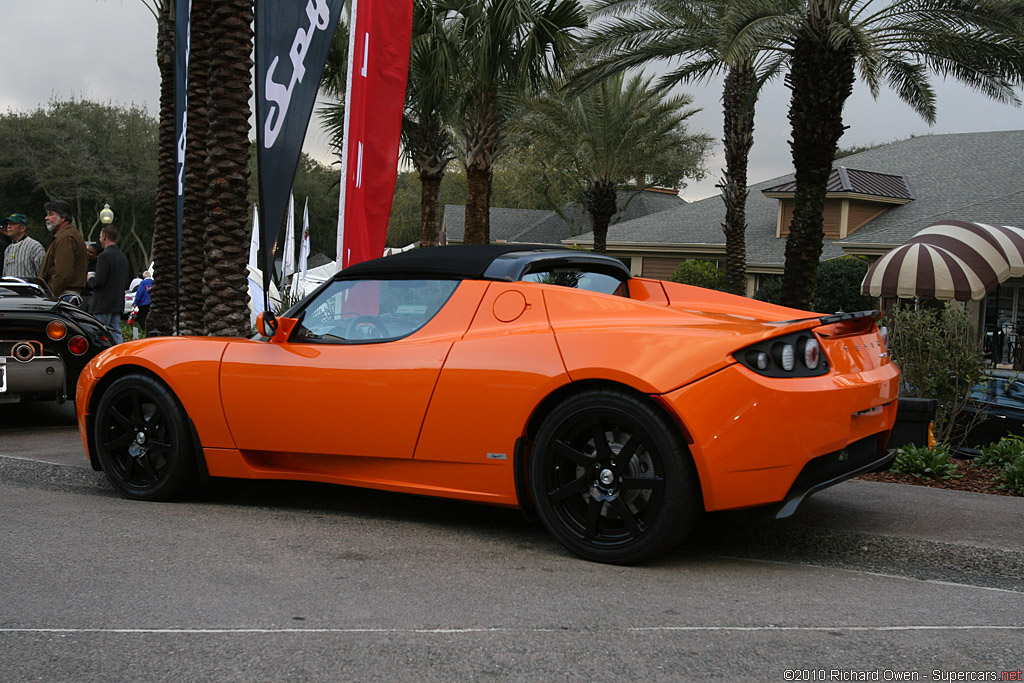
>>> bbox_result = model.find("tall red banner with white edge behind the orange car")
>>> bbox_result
[337,0,413,269]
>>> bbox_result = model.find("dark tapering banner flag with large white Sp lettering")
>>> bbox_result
[256,0,345,310]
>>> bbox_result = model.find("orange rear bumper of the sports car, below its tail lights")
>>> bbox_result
[662,364,899,514]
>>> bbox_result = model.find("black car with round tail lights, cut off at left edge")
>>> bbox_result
[0,278,113,403]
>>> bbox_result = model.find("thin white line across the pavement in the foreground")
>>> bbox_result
[0,624,1024,635]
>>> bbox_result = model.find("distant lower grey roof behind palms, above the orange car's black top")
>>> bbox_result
[444,189,685,245]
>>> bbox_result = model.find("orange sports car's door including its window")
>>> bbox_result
[220,281,486,458]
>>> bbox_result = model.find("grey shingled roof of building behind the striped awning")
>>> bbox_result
[572,130,1024,266]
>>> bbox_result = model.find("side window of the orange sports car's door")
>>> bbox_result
[292,280,459,343]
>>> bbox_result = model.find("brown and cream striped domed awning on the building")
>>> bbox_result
[861,221,1024,301]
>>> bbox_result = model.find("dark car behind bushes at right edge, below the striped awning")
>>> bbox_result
[957,373,1024,455]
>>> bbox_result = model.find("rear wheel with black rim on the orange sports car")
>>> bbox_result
[529,390,703,564]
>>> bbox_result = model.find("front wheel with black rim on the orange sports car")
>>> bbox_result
[93,374,199,501]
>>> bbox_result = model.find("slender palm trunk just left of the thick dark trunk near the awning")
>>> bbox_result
[719,61,758,295]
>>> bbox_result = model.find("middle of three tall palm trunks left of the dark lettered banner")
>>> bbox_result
[180,0,214,335]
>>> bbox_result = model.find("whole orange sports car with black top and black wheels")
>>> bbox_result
[77,245,899,563]
